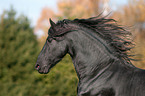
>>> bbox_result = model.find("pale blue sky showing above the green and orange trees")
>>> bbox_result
[0,0,128,26]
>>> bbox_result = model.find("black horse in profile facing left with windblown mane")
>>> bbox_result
[35,17,145,96]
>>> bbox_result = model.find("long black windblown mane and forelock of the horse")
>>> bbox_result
[48,17,132,63]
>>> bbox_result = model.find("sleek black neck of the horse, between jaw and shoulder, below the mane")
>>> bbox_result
[67,33,113,79]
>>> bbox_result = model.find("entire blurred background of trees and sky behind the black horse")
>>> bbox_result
[0,0,145,96]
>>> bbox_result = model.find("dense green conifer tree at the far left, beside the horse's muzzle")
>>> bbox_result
[0,8,39,96]
